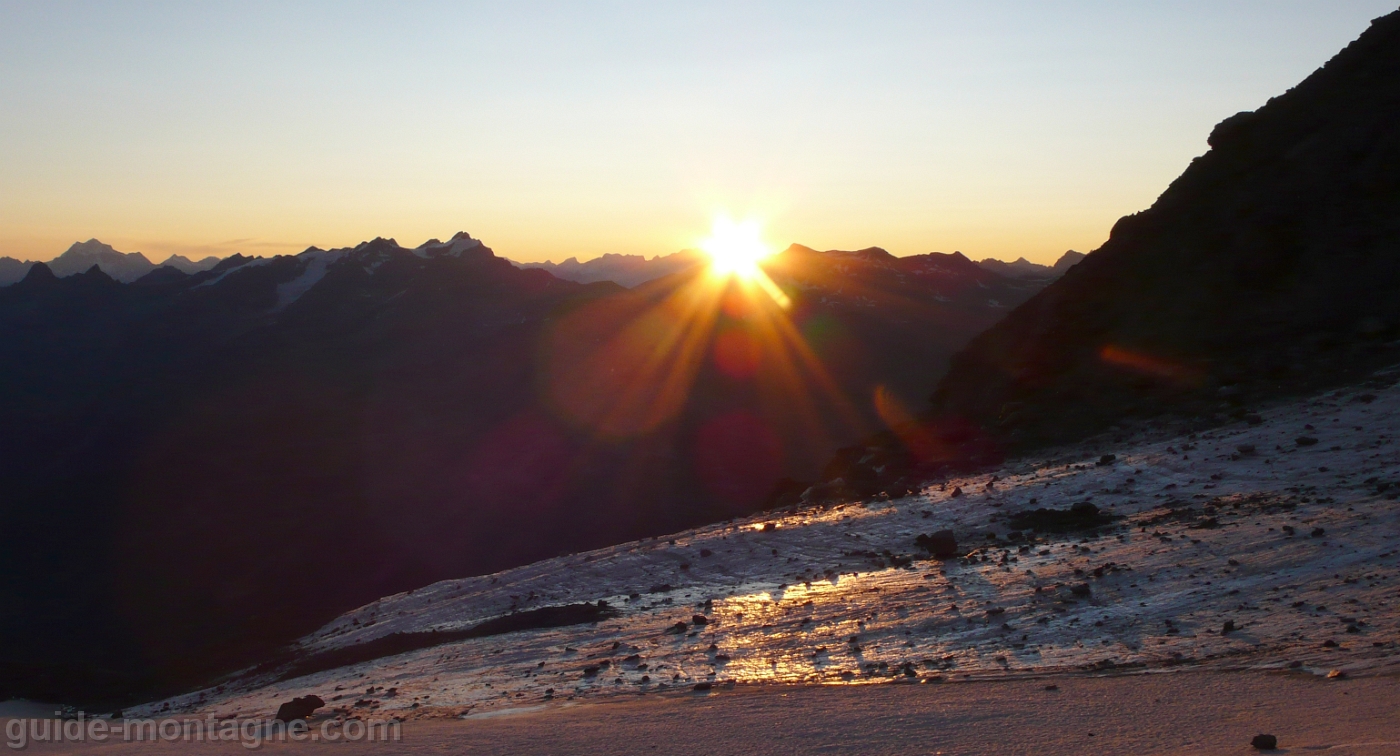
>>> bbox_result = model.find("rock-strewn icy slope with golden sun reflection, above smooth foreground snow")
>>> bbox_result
[139,375,1400,717]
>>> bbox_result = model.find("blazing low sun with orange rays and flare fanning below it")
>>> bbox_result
[539,212,868,467]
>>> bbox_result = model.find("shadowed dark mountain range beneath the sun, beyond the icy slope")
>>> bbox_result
[0,234,1039,701]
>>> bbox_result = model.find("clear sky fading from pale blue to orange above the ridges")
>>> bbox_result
[0,0,1396,262]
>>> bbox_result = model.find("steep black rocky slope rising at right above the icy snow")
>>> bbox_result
[932,8,1400,447]
